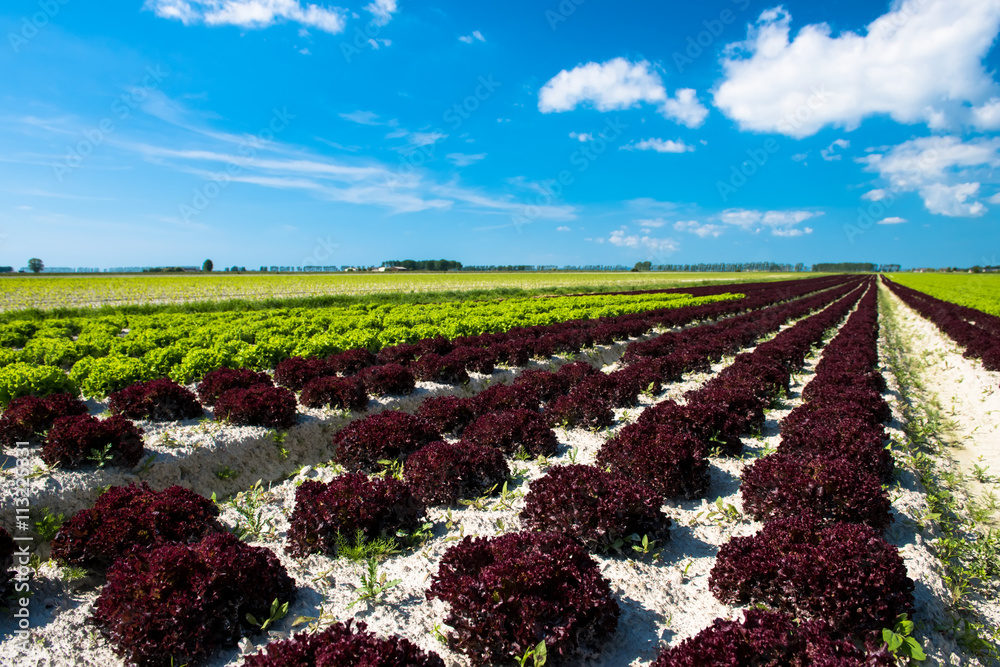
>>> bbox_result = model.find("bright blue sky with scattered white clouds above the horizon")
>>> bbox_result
[0,0,1000,267]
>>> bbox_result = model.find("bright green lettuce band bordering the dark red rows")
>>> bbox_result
[0,277,860,404]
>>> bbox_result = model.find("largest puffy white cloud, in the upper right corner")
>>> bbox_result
[714,0,1000,137]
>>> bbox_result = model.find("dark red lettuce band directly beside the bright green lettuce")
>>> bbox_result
[0,276,860,480]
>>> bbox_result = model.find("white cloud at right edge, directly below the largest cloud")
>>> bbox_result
[858,136,1000,217]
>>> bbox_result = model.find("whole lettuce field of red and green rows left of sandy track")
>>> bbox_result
[0,276,1000,667]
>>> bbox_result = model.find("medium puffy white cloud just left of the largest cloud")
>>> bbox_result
[538,58,708,127]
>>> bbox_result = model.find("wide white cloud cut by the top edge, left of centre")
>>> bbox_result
[143,0,348,34]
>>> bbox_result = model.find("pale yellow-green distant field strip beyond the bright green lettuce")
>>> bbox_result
[0,273,803,312]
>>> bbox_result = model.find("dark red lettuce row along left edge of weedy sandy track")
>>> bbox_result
[657,289,919,667]
